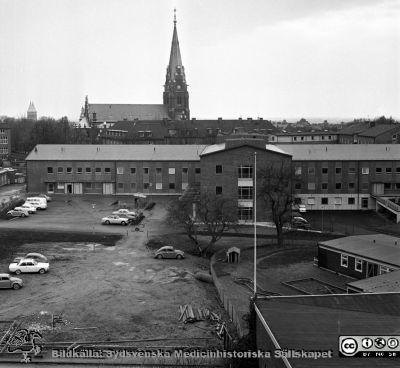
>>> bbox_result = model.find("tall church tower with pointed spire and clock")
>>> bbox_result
[163,10,190,120]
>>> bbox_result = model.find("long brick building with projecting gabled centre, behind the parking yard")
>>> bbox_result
[26,138,400,220]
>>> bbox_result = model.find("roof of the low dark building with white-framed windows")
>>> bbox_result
[319,234,400,267]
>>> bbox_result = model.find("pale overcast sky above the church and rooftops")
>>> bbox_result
[0,0,400,120]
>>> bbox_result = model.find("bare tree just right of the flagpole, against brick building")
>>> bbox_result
[258,161,294,246]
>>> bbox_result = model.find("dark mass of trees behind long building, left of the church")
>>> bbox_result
[4,117,90,153]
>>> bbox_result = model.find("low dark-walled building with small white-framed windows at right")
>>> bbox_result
[318,234,400,279]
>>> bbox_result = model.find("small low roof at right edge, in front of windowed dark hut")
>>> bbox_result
[347,270,400,293]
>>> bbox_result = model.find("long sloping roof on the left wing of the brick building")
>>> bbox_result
[26,144,205,161]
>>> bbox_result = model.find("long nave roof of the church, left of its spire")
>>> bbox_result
[89,104,168,124]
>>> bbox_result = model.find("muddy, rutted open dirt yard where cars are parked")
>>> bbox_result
[0,198,223,347]
